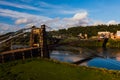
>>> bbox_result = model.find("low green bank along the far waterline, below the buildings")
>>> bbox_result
[60,38,120,48]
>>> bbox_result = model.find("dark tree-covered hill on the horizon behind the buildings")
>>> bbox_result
[50,24,120,38]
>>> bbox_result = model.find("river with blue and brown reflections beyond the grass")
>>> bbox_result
[50,46,120,70]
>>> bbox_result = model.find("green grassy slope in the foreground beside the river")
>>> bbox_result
[0,59,120,80]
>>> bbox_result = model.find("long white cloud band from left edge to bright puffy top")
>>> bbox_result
[0,9,90,29]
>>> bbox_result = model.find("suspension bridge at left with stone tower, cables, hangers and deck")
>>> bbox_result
[0,25,50,63]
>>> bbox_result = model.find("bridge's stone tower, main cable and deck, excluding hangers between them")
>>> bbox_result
[0,25,50,63]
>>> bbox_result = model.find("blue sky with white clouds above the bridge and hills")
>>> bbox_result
[0,0,120,34]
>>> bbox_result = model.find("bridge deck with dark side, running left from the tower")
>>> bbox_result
[0,47,41,63]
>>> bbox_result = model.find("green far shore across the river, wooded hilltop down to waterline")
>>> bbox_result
[49,24,120,48]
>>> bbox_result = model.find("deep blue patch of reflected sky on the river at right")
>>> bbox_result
[88,58,120,70]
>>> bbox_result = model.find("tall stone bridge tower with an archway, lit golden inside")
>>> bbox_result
[30,25,50,58]
